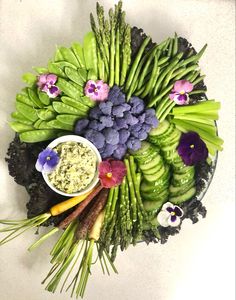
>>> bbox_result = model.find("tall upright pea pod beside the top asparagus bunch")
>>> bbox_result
[83,31,98,76]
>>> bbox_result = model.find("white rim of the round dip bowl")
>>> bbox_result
[42,134,102,197]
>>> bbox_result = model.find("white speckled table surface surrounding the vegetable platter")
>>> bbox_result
[0,0,235,300]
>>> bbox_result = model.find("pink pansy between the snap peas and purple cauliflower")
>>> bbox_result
[84,80,109,101]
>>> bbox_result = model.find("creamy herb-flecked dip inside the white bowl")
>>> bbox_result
[48,142,97,194]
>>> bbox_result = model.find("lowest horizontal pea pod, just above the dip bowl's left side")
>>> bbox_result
[20,129,58,143]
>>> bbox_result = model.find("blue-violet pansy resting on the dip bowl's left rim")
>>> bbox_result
[35,148,59,174]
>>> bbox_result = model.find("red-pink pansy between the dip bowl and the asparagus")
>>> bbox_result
[98,160,126,188]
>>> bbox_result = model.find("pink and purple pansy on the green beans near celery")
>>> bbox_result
[169,80,193,105]
